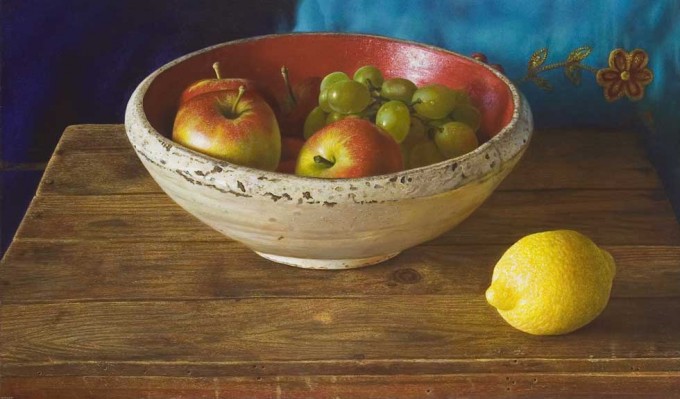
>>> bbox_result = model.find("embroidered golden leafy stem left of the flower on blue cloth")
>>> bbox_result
[520,46,598,91]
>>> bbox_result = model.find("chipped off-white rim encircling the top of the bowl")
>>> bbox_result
[125,32,533,202]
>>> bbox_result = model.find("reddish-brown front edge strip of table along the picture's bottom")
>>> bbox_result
[2,373,680,399]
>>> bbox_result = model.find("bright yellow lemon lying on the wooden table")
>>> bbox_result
[486,230,616,335]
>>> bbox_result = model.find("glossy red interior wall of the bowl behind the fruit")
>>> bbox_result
[144,34,514,139]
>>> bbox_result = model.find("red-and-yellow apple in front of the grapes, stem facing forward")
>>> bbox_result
[295,118,404,178]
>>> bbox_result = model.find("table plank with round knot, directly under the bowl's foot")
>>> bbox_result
[0,240,680,304]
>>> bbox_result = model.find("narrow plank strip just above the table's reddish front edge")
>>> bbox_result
[6,357,680,378]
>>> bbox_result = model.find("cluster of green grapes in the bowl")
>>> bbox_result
[304,65,481,168]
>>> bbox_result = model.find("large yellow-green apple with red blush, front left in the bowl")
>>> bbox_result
[172,86,281,170]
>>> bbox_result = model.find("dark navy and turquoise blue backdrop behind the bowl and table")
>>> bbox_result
[0,0,680,255]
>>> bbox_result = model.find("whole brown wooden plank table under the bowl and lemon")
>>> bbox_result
[0,125,680,399]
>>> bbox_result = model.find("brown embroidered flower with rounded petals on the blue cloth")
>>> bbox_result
[597,48,654,101]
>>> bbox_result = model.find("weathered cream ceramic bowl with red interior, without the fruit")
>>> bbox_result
[125,33,533,269]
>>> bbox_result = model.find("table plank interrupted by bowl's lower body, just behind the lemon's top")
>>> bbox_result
[17,190,680,245]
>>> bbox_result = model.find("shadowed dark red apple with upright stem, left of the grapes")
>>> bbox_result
[277,66,321,137]
